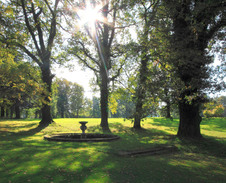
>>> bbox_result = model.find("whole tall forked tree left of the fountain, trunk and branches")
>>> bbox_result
[0,0,60,126]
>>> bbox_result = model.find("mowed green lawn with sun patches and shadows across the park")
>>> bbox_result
[0,118,226,183]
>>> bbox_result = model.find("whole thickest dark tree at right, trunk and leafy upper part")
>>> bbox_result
[163,0,226,138]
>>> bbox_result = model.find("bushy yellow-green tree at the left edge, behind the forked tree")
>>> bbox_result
[0,47,44,119]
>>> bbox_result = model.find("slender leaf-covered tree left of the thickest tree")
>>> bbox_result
[126,0,159,129]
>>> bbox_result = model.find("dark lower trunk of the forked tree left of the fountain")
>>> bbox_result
[39,61,53,126]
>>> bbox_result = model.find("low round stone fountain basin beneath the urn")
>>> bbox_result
[44,133,120,142]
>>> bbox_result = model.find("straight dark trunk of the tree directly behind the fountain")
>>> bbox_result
[100,68,110,132]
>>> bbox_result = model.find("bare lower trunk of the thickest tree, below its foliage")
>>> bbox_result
[177,100,202,138]
